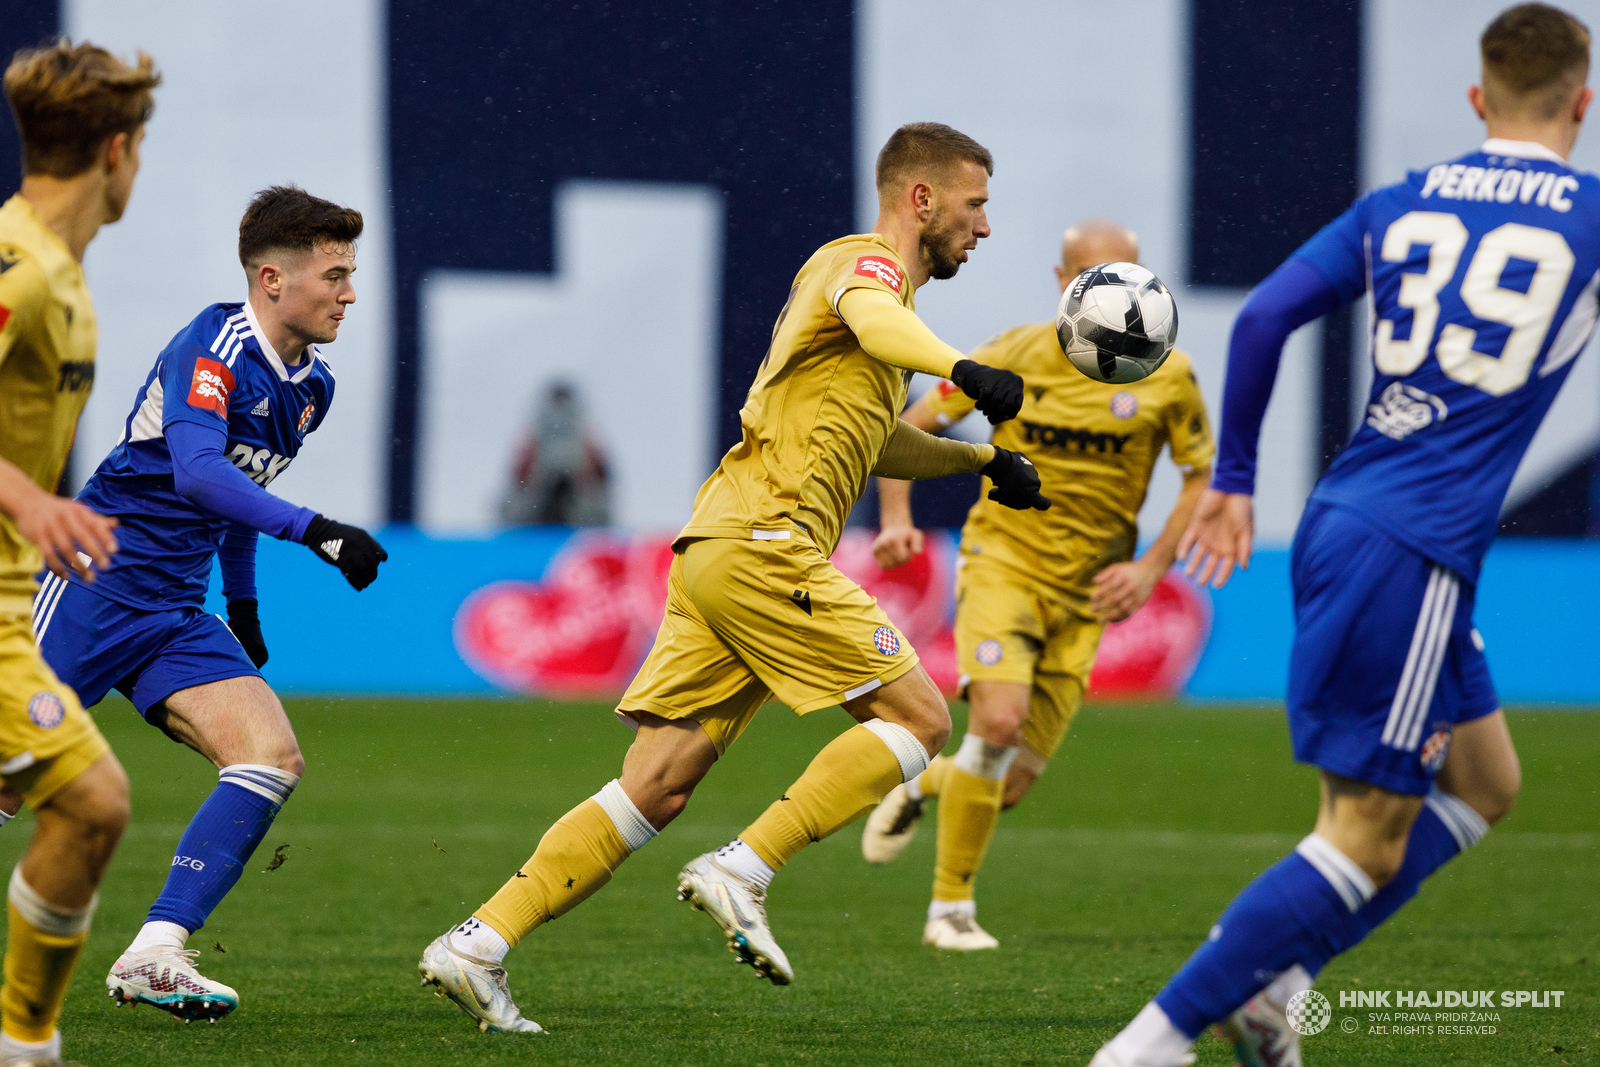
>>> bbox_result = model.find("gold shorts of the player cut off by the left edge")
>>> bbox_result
[0,614,110,808]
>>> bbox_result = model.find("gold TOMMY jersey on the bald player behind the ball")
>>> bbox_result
[928,323,1214,611]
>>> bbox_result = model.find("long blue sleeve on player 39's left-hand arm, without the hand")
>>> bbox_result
[1211,254,1360,493]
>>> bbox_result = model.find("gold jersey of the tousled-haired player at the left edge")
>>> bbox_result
[0,195,96,614]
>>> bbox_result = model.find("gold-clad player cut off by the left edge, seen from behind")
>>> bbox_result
[0,42,160,1067]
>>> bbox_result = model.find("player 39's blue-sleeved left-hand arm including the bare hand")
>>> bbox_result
[1178,203,1366,589]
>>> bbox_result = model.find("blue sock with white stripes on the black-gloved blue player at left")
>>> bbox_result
[147,763,299,934]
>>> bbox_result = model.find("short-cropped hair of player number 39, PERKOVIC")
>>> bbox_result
[1478,3,1589,118]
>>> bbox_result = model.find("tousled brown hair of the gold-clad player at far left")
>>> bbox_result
[5,37,162,178]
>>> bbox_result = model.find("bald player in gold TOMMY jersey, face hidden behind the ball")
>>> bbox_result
[861,219,1213,949]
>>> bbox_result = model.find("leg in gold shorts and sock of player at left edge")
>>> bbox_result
[0,617,128,1064]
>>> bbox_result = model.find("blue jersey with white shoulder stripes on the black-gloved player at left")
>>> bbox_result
[78,304,333,611]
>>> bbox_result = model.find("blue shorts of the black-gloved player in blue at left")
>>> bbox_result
[34,574,261,718]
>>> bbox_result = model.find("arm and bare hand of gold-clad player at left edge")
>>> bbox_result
[0,248,117,581]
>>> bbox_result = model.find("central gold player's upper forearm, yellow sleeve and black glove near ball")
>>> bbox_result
[838,288,1022,422]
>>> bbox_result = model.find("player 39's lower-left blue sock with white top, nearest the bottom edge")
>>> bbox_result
[1155,833,1376,1040]
